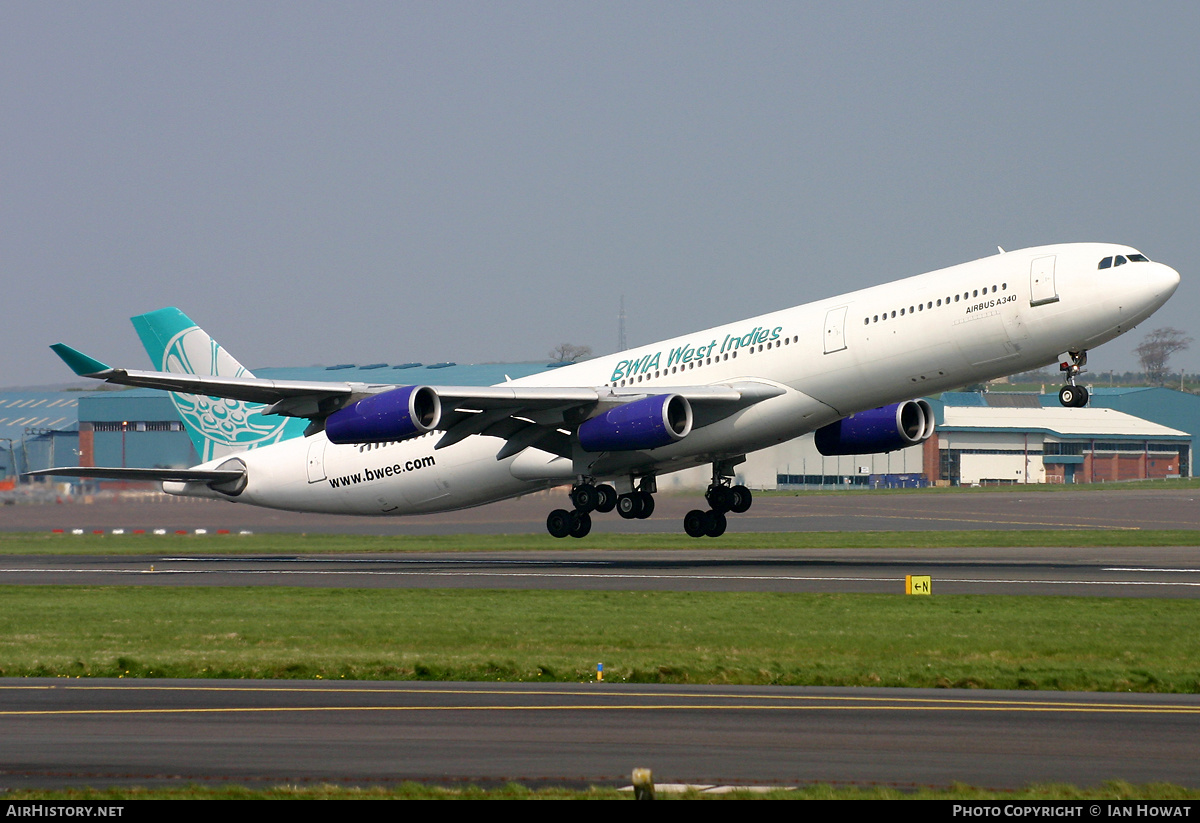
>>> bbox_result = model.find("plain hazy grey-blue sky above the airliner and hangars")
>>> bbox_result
[0,0,1200,385]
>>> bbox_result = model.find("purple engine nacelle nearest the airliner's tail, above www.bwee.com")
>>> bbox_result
[325,386,442,444]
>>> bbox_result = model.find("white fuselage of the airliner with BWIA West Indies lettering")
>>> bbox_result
[171,244,1180,515]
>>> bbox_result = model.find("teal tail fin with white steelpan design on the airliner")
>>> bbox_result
[131,308,307,463]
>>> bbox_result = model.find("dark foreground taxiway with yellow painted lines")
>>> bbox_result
[0,680,1200,788]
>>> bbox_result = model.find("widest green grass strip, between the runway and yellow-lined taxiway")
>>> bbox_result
[0,585,1200,692]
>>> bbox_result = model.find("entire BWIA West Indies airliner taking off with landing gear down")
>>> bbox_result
[30,244,1180,537]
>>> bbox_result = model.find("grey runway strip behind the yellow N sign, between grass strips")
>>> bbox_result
[7,547,1200,599]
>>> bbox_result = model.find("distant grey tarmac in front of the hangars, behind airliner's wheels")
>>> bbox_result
[9,486,1200,542]
